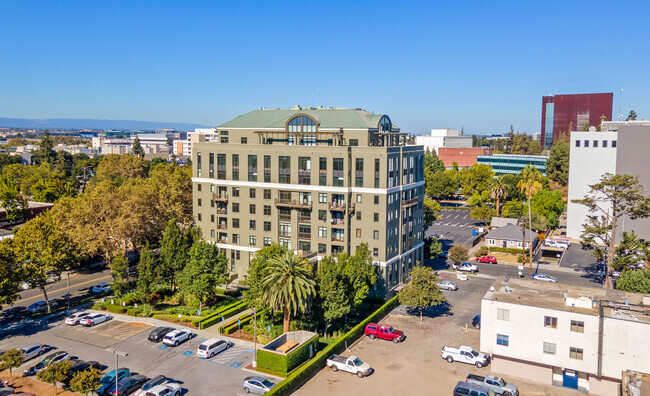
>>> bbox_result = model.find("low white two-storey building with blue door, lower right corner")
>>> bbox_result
[481,279,650,396]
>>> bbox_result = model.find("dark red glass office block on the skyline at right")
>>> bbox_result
[541,92,614,147]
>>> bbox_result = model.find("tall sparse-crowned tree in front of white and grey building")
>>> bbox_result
[573,173,650,289]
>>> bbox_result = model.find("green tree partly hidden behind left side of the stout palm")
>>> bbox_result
[243,243,288,311]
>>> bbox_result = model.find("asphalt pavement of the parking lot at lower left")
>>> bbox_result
[0,312,262,395]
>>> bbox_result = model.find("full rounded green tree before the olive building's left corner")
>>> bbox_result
[178,240,229,311]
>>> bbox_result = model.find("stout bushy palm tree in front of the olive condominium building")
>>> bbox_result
[261,252,316,333]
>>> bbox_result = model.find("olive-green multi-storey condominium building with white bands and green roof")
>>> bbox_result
[192,106,424,293]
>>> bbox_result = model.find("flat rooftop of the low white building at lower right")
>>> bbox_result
[483,277,650,324]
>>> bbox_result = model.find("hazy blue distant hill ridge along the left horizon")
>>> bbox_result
[0,117,207,131]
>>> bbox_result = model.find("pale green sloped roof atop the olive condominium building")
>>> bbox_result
[219,108,392,129]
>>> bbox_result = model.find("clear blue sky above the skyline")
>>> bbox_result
[0,0,650,133]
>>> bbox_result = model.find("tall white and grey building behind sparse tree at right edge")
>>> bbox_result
[567,121,650,239]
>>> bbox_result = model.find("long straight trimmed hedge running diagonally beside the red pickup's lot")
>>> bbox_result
[258,296,399,396]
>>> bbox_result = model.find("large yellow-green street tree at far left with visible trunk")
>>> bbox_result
[13,211,79,312]
